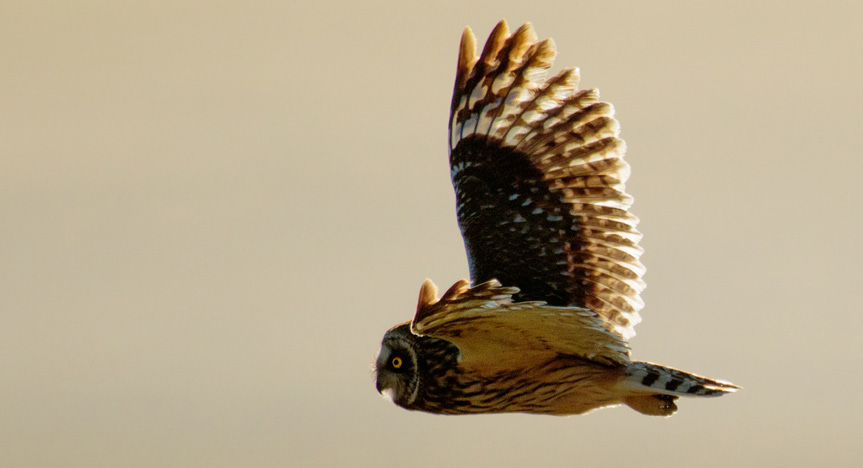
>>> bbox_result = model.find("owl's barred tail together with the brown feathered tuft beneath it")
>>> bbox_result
[620,361,740,416]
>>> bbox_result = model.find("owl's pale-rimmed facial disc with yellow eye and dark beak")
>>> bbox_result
[375,323,420,407]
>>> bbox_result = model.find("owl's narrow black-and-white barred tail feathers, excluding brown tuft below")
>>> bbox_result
[621,361,740,397]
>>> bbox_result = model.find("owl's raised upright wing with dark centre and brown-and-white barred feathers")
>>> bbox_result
[449,21,644,339]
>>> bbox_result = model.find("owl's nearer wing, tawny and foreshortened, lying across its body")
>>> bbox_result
[411,280,629,371]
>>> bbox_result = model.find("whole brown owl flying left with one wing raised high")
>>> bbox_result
[375,21,738,416]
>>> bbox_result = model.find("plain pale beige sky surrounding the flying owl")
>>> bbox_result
[0,0,863,468]
